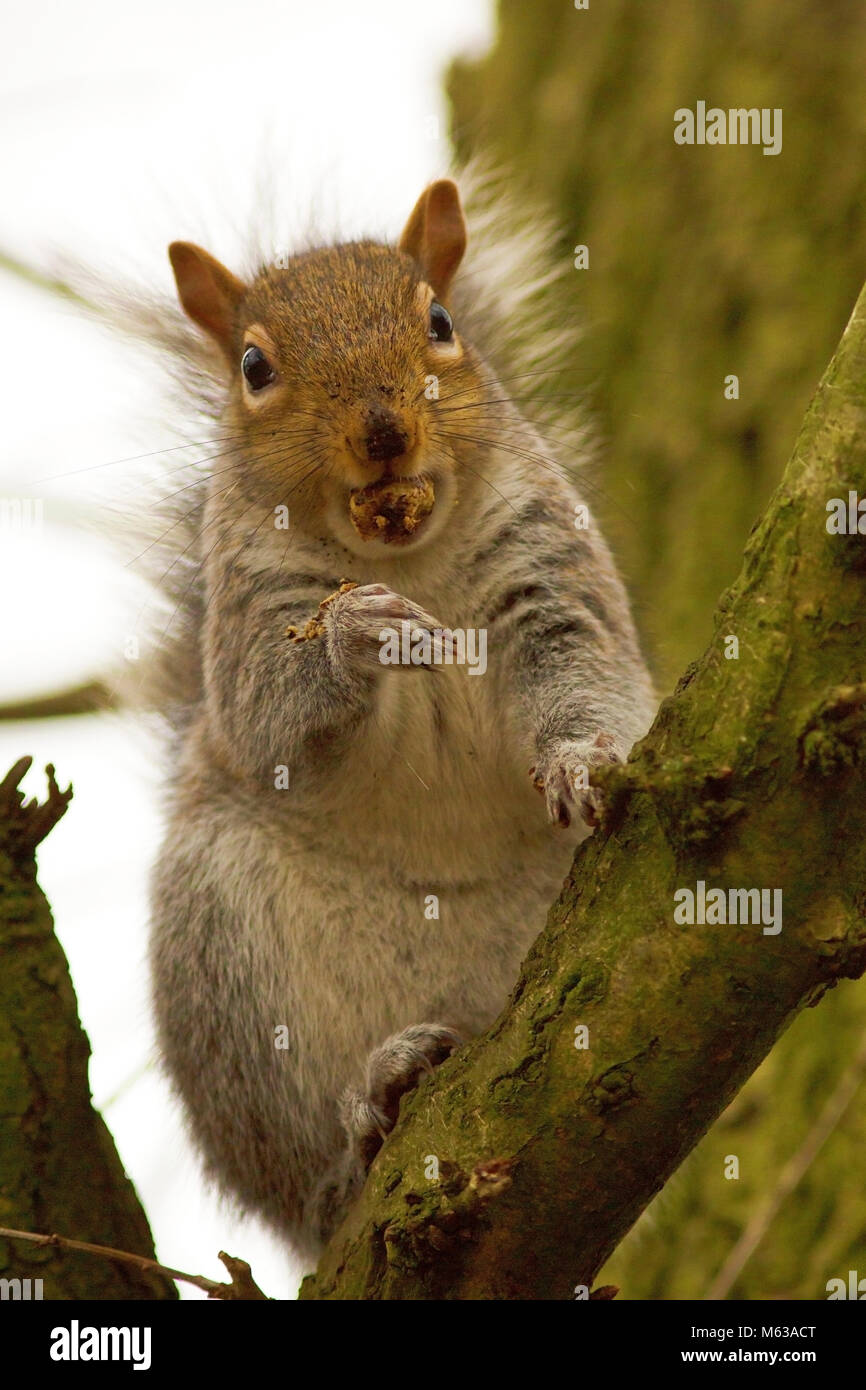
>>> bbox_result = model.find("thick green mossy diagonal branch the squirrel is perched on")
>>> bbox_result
[302,276,866,1300]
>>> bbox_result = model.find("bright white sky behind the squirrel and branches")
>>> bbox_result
[0,0,492,1297]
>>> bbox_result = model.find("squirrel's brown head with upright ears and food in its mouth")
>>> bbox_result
[168,179,481,553]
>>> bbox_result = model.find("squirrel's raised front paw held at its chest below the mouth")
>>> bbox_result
[322,584,452,670]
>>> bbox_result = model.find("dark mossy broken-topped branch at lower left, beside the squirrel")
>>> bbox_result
[0,758,177,1300]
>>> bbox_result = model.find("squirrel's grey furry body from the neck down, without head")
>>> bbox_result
[143,170,653,1259]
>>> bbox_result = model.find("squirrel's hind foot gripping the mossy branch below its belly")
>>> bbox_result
[341,1023,463,1168]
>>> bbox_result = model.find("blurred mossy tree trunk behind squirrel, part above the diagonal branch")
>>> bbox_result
[448,0,866,691]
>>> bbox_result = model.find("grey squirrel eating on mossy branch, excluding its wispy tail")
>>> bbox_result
[142,179,655,1262]
